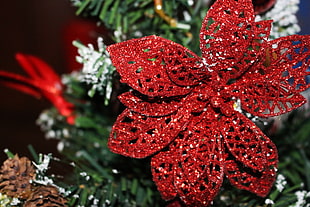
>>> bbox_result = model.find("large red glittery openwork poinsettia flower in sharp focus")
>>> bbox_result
[108,0,310,206]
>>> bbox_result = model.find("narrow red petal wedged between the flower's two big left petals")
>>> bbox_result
[118,92,182,116]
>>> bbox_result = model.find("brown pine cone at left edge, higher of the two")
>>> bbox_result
[0,155,36,199]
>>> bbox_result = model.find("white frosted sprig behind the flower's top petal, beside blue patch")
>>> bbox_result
[256,0,300,39]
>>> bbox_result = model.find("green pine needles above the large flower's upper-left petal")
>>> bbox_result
[71,0,208,53]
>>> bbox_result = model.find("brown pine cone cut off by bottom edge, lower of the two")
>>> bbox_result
[24,185,67,207]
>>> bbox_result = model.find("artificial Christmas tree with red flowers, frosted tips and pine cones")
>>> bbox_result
[0,0,310,206]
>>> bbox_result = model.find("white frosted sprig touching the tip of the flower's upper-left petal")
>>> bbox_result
[73,37,115,105]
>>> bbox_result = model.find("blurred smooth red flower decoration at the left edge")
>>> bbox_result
[0,53,75,124]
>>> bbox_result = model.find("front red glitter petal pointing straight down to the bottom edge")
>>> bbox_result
[174,115,224,206]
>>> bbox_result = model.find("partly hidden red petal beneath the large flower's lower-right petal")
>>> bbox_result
[225,160,277,197]
